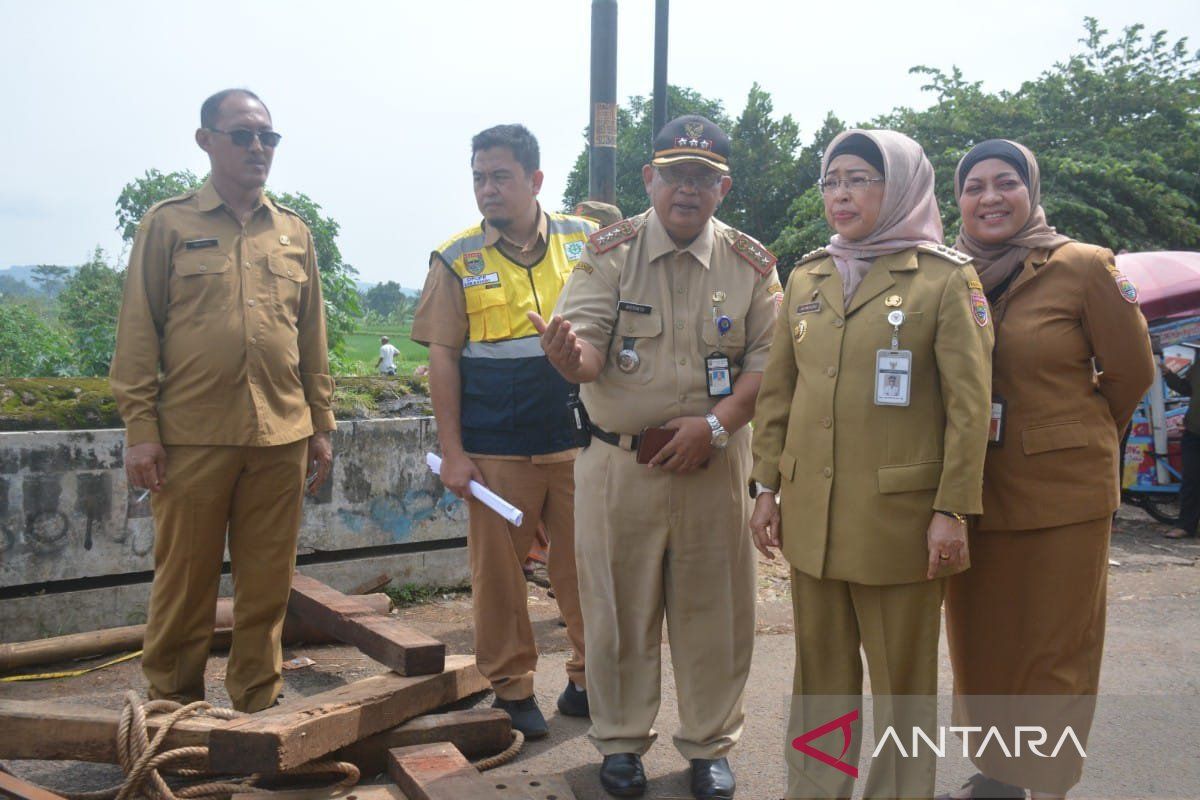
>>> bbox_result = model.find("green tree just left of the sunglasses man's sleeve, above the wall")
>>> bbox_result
[59,247,125,375]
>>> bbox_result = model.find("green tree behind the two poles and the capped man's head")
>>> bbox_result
[563,86,732,216]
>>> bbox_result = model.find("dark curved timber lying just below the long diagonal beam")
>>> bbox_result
[331,708,512,775]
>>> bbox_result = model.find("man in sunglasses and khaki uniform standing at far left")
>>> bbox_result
[110,89,336,711]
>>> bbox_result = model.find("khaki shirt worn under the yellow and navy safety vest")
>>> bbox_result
[412,205,578,464]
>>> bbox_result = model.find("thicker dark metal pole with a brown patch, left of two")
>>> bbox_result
[588,0,617,203]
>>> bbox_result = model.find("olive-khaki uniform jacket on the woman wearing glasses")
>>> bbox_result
[752,246,992,585]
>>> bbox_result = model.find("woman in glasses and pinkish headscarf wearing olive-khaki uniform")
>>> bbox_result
[750,131,992,798]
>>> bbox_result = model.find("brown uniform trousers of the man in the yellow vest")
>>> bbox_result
[467,456,587,700]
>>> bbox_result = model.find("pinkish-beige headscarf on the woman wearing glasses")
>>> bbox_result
[821,130,942,305]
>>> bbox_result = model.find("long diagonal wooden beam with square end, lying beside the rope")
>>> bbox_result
[209,656,488,774]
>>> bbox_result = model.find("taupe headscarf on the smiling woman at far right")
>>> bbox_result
[954,139,1070,293]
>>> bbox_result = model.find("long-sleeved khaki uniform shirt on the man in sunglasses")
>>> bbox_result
[110,177,336,446]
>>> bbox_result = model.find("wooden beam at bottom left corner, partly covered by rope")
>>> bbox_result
[0,700,219,764]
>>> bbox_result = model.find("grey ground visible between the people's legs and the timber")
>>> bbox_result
[0,507,1200,800]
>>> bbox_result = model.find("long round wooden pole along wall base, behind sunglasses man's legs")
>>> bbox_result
[0,594,391,672]
